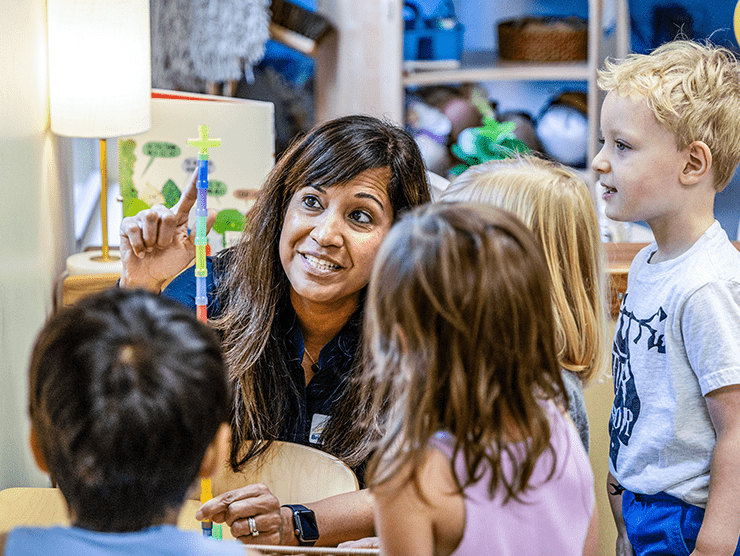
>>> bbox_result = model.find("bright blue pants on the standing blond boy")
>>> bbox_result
[622,490,740,556]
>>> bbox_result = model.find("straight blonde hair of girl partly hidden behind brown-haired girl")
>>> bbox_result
[440,155,609,384]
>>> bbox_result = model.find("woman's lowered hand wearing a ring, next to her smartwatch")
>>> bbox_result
[195,483,293,545]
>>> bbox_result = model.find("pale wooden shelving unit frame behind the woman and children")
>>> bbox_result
[316,0,629,185]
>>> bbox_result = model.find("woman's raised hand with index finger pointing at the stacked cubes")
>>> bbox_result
[120,171,217,292]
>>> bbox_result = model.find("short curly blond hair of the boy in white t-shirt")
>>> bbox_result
[598,40,740,191]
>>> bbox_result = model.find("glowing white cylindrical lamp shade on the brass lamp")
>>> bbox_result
[47,0,151,138]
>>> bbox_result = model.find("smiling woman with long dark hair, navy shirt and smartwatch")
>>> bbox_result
[120,116,430,546]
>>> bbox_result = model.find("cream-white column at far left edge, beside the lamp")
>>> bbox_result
[0,0,74,489]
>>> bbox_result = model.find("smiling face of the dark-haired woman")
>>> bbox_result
[280,168,393,310]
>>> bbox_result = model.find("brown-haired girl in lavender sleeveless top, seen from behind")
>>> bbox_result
[364,203,596,556]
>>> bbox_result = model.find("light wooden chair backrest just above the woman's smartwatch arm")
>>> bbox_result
[191,441,360,504]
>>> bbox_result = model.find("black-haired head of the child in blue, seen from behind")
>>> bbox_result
[29,289,231,531]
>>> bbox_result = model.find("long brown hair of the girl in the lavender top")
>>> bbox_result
[363,203,564,500]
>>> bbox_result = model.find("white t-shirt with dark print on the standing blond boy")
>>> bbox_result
[609,221,740,507]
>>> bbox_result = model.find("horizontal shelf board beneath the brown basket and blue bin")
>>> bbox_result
[402,51,592,87]
